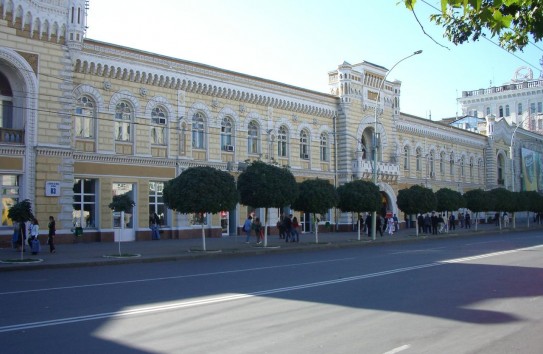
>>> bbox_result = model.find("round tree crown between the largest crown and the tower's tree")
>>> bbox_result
[291,178,338,214]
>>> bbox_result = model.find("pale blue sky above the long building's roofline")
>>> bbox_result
[87,0,543,120]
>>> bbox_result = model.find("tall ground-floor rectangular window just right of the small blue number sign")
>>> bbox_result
[72,178,97,228]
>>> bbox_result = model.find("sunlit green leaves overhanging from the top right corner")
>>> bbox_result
[402,0,543,52]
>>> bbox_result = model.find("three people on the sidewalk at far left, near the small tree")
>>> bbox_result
[12,216,56,255]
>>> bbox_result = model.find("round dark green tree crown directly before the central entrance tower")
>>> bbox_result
[337,180,381,213]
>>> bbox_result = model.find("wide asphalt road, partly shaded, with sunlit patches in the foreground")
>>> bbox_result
[0,230,543,354]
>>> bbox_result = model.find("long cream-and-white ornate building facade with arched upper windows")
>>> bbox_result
[0,0,541,241]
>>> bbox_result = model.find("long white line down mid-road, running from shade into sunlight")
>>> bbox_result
[0,245,543,334]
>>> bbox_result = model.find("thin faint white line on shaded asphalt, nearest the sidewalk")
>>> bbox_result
[0,257,355,296]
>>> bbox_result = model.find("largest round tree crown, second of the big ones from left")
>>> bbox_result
[237,161,299,208]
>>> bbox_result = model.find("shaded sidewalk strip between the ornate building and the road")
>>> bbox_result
[0,223,543,272]
